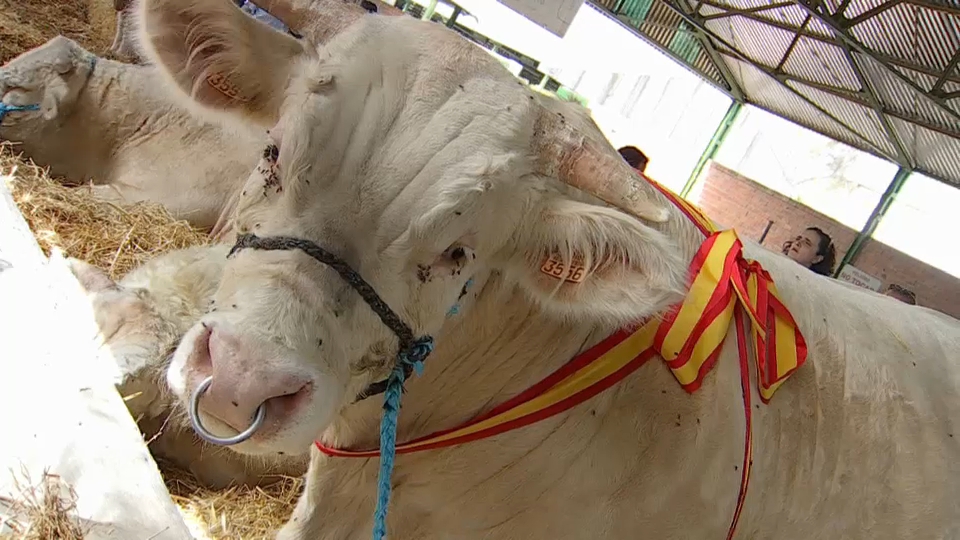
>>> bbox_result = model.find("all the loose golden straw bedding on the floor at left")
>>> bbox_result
[0,0,302,540]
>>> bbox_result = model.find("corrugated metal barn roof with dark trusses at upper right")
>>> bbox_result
[591,0,960,187]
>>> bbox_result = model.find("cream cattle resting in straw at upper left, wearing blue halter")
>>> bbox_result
[0,36,262,232]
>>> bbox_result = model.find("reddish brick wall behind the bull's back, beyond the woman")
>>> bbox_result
[693,162,960,318]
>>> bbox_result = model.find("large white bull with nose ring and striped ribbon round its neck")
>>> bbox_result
[127,0,960,540]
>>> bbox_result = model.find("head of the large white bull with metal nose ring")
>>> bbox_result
[140,0,685,453]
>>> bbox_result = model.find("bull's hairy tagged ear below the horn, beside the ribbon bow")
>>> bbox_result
[508,199,687,324]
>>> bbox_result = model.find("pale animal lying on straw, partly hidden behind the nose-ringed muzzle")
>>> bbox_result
[70,245,308,489]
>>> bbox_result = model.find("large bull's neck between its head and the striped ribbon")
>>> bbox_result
[326,186,704,449]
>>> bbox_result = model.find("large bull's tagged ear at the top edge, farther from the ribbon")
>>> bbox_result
[137,0,306,128]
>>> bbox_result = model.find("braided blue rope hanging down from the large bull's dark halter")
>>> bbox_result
[373,336,433,540]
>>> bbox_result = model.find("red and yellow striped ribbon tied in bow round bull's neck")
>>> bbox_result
[316,176,807,540]
